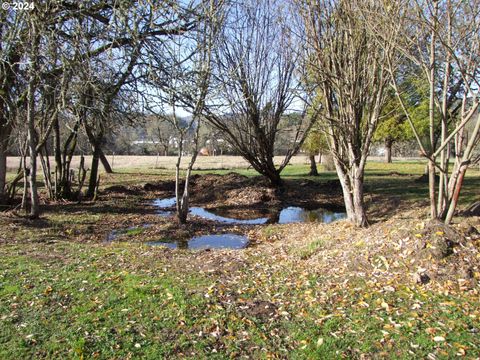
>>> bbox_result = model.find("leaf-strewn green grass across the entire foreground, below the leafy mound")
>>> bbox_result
[0,243,480,359]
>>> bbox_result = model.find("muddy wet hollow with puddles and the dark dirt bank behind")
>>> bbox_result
[106,173,346,249]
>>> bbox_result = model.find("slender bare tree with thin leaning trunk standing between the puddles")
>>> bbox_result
[147,0,224,224]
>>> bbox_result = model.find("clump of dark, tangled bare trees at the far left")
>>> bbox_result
[0,0,209,217]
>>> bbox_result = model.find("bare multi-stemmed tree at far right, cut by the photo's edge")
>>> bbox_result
[386,0,480,224]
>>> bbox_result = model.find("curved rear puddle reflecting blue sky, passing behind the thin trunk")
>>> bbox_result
[153,198,346,225]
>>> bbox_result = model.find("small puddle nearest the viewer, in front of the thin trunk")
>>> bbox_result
[146,234,248,249]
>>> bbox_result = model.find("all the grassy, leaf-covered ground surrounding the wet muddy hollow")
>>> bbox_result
[0,161,480,359]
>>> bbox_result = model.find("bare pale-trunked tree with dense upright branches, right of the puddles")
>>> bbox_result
[299,0,399,226]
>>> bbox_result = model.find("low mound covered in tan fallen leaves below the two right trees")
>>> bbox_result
[260,207,480,291]
